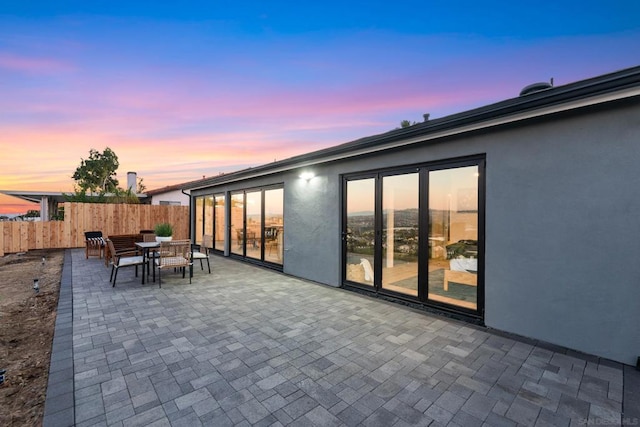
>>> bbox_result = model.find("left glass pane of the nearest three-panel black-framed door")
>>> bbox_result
[345,178,376,286]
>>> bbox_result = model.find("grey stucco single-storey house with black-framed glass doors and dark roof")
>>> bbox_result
[183,67,640,364]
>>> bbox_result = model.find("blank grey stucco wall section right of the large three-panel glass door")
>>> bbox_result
[485,102,640,364]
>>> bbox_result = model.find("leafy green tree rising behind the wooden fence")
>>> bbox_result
[72,147,120,194]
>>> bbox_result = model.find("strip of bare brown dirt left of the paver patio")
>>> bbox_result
[0,250,64,426]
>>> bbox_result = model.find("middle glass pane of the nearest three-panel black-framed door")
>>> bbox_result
[382,173,419,297]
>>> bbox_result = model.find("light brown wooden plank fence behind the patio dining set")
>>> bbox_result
[0,202,189,256]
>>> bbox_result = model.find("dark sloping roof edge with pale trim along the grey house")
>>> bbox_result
[182,66,640,191]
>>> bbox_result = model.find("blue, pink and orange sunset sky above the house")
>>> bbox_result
[0,0,640,214]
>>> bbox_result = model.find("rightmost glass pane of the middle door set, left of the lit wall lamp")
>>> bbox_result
[264,188,284,264]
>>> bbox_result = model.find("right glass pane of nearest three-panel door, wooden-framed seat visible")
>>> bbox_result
[428,166,479,310]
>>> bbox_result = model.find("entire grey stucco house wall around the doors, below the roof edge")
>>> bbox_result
[193,100,640,364]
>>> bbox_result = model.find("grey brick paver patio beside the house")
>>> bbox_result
[44,250,640,426]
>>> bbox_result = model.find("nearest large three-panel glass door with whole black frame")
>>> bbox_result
[343,157,484,317]
